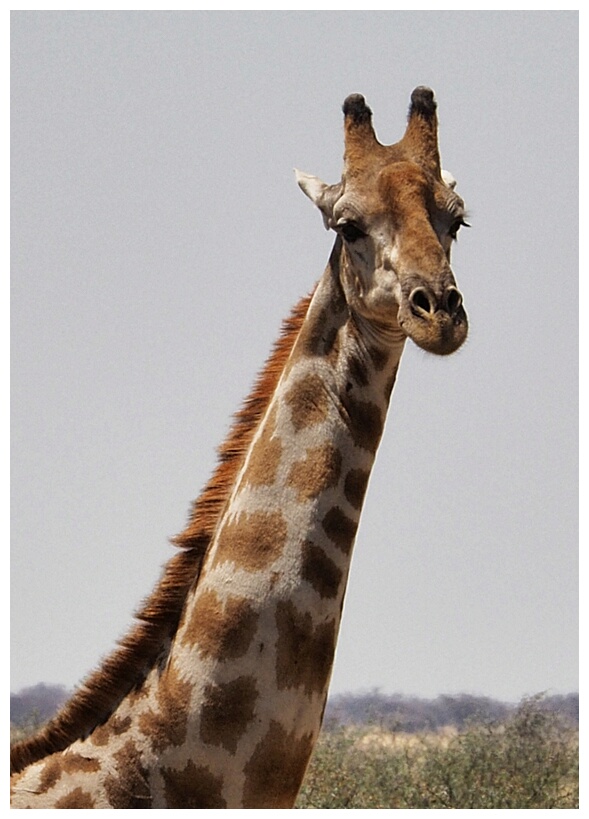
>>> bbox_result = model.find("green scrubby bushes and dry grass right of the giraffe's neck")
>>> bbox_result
[297,698,579,809]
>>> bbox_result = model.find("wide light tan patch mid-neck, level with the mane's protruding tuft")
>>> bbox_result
[215,512,287,572]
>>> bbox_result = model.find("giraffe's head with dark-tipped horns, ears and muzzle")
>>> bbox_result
[297,87,468,355]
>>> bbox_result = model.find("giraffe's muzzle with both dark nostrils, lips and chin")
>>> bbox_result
[398,285,468,355]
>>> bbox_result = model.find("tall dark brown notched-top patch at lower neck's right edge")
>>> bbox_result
[276,602,336,694]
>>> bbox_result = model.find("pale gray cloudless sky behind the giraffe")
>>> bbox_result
[11,11,578,700]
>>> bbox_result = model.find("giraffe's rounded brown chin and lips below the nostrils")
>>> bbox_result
[398,305,468,355]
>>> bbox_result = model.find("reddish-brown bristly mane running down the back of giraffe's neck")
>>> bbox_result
[10,295,311,773]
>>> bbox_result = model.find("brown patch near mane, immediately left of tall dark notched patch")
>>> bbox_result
[184,590,258,660]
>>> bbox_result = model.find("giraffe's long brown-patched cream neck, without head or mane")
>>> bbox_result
[10,240,403,808]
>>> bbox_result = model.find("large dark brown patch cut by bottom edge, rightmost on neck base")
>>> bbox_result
[243,720,314,808]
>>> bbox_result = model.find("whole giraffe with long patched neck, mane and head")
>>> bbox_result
[11,87,468,808]
